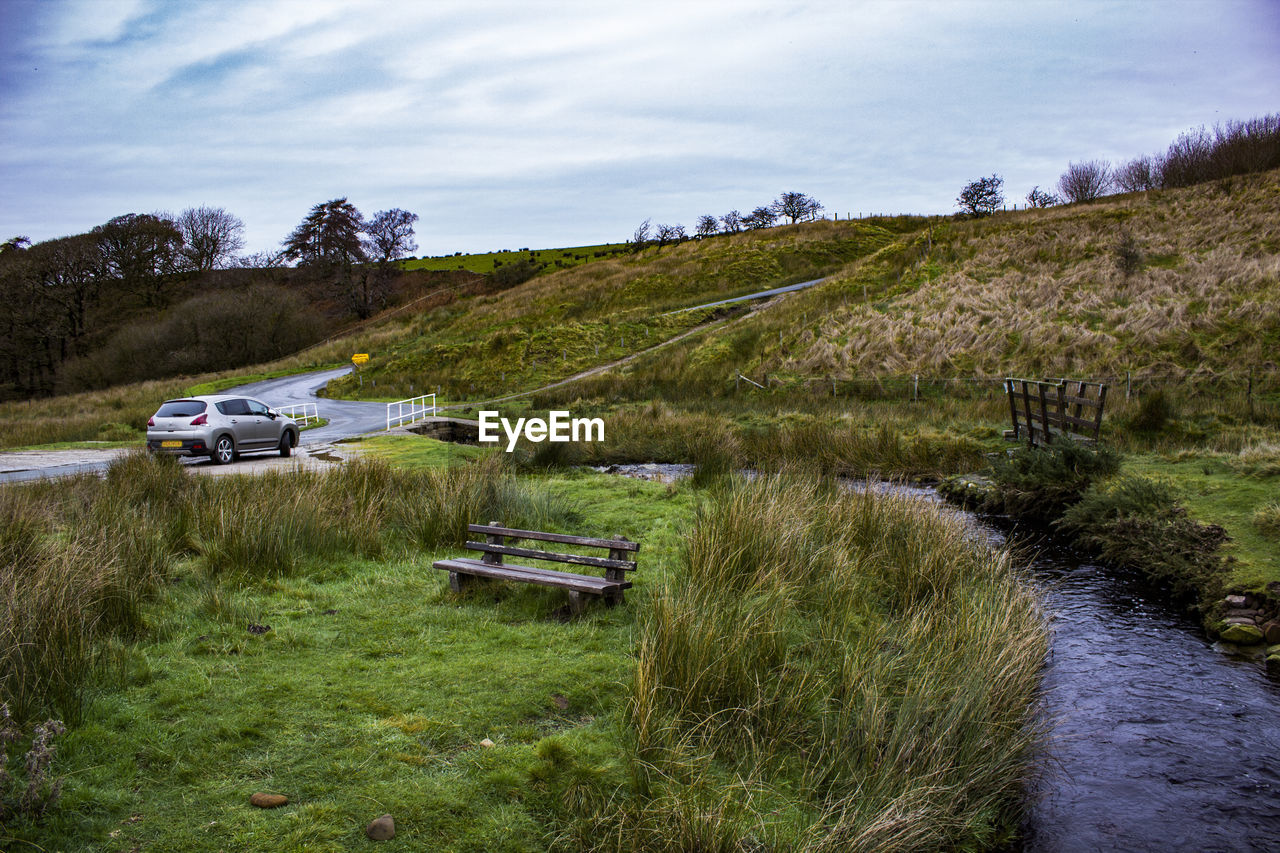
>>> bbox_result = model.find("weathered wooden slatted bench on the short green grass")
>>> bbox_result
[431,521,640,613]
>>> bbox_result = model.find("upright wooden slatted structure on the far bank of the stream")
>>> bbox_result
[1005,379,1107,447]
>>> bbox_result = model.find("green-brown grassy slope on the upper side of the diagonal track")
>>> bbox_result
[330,219,923,400]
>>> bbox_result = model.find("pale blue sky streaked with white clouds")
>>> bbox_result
[0,0,1280,254]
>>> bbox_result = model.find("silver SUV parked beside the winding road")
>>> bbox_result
[147,394,298,465]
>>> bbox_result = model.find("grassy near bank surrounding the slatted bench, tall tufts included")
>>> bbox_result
[0,437,1043,850]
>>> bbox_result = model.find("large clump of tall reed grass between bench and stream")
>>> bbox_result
[566,474,1046,850]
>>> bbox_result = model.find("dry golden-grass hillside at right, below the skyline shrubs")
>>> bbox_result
[721,172,1280,377]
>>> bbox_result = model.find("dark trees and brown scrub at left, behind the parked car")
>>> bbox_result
[0,199,417,400]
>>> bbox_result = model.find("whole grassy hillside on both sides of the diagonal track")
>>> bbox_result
[322,172,1280,400]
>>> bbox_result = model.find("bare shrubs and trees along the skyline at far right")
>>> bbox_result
[956,114,1280,216]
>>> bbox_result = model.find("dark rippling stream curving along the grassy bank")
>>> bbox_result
[601,465,1280,853]
